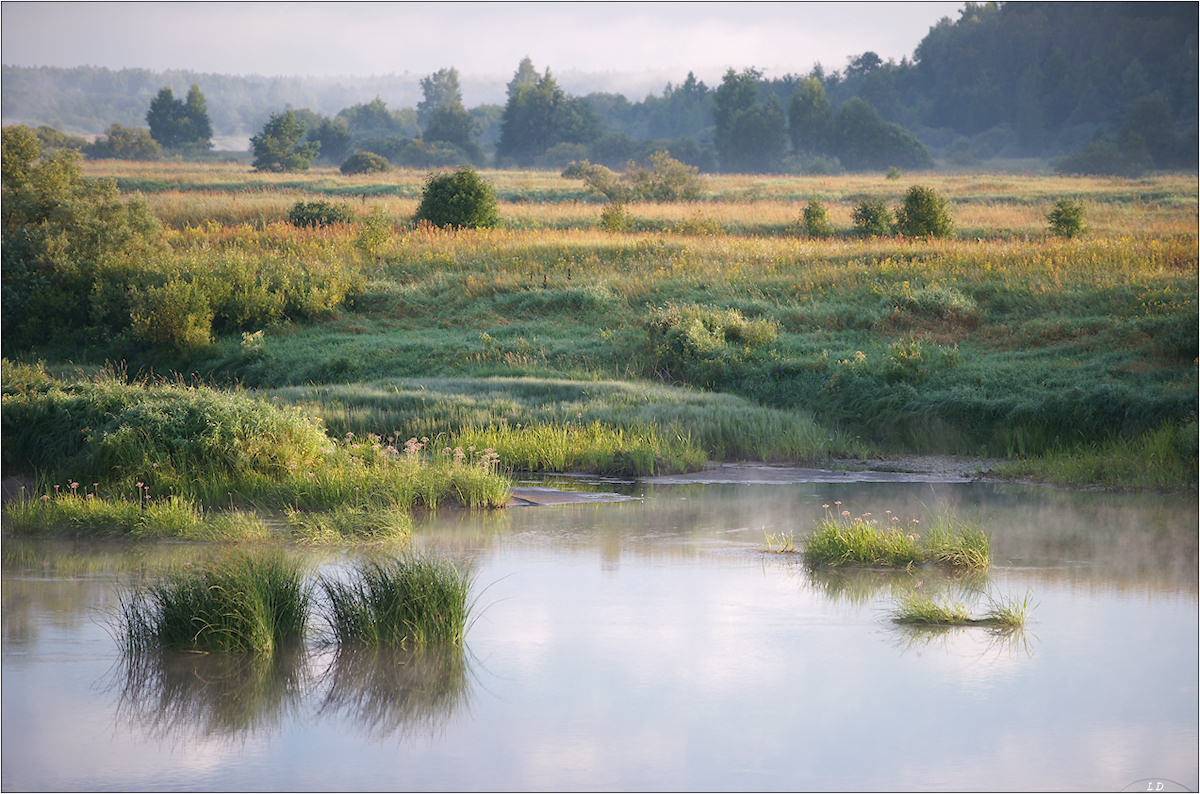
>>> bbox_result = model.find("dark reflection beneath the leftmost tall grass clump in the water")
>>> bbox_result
[114,648,311,740]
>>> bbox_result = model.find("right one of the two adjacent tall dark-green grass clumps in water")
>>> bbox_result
[320,555,470,646]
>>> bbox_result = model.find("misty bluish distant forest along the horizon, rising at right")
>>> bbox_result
[2,2,1198,173]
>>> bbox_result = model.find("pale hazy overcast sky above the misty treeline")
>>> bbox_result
[0,0,962,99]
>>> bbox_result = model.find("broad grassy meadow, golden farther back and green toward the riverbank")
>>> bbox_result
[5,161,1198,498]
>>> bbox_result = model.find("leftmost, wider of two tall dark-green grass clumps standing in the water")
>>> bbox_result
[121,551,311,655]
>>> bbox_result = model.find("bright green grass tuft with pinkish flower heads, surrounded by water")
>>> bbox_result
[804,503,991,571]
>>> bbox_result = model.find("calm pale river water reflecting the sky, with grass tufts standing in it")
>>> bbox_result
[0,474,1198,790]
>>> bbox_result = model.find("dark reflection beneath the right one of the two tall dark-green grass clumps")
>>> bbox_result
[319,645,470,739]
